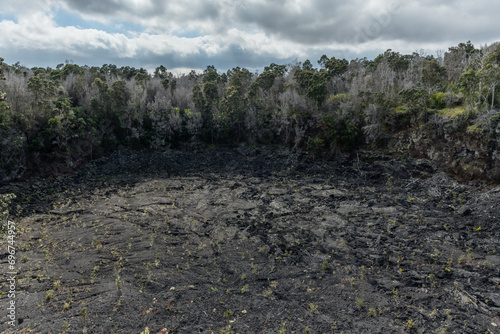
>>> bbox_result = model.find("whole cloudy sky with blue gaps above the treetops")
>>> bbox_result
[0,0,500,72]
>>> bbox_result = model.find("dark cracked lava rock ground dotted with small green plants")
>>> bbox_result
[0,147,500,334]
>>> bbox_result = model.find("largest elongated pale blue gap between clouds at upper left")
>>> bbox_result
[54,10,144,35]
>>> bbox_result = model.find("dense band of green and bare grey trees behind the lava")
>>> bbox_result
[0,42,500,181]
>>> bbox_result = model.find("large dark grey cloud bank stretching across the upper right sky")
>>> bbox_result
[53,0,500,46]
